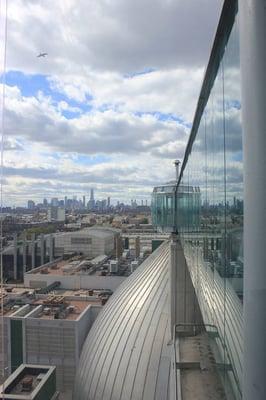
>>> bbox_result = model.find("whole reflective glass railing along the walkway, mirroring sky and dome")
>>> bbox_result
[177,1,244,396]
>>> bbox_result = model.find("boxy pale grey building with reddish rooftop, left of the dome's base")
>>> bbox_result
[1,287,103,393]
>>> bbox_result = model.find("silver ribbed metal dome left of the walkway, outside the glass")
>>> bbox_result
[73,243,171,400]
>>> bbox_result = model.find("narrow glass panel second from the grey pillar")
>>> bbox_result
[210,56,228,383]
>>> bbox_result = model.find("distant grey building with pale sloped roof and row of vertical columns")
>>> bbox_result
[3,228,118,281]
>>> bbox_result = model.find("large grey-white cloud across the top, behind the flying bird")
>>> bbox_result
[8,0,222,74]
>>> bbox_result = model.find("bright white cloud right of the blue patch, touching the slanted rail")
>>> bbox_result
[52,67,203,122]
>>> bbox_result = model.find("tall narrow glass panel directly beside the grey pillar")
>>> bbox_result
[224,15,243,396]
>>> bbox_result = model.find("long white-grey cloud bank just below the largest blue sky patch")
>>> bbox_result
[5,88,188,155]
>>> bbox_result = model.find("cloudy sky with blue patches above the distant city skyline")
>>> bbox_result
[0,0,222,206]
